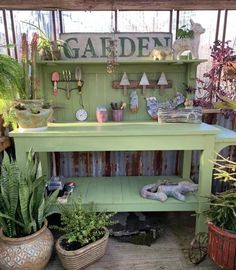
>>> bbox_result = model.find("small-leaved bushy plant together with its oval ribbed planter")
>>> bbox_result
[54,200,113,270]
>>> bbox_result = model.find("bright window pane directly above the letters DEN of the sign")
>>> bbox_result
[118,11,170,32]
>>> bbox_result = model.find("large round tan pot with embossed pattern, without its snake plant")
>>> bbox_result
[0,221,54,270]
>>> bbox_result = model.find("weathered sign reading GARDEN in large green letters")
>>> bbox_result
[60,32,172,60]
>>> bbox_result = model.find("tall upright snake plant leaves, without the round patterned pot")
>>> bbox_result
[0,151,58,237]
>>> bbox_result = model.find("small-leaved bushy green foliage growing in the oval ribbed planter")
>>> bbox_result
[53,199,114,250]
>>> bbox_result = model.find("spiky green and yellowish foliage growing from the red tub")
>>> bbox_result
[204,155,236,232]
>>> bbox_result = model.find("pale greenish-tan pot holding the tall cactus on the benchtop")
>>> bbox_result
[15,108,53,131]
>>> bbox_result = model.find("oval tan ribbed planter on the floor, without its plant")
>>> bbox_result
[56,228,109,270]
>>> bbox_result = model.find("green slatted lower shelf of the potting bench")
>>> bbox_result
[67,176,198,212]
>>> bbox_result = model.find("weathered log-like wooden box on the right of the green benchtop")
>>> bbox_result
[158,107,202,124]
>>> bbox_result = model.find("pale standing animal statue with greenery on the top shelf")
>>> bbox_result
[173,19,205,59]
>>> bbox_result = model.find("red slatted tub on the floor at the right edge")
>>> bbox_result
[208,222,236,270]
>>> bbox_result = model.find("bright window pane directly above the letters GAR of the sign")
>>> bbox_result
[62,11,115,33]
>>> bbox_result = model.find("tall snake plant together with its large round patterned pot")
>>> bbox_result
[0,151,58,270]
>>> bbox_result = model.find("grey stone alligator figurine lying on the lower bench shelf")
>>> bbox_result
[140,181,198,202]
